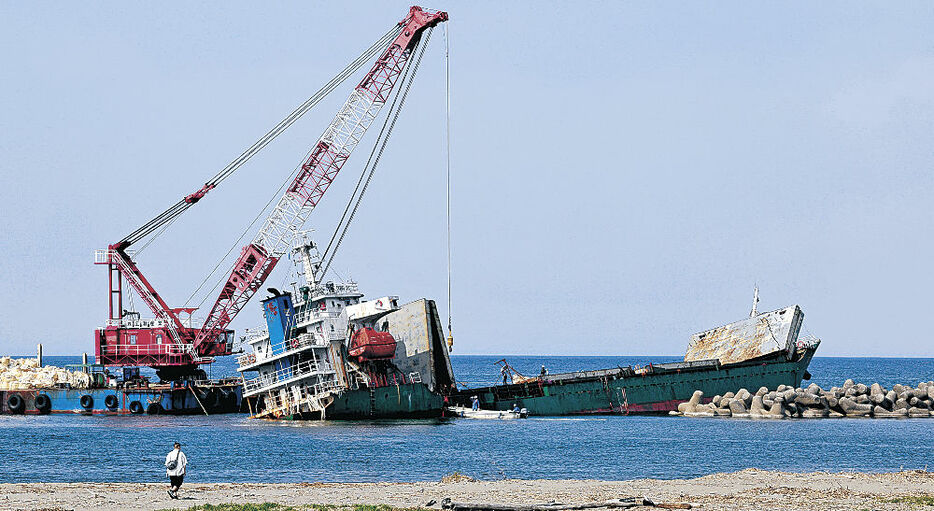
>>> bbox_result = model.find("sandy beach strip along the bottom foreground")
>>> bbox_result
[0,469,934,511]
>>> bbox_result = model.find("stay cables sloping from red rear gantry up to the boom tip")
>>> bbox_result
[121,25,402,250]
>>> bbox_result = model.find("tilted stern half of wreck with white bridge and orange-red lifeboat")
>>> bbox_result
[238,239,454,419]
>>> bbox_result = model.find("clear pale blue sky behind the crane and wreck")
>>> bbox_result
[0,1,934,357]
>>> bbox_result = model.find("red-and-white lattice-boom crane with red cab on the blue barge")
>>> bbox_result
[94,6,448,388]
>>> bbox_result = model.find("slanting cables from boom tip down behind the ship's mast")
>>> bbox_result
[321,27,434,276]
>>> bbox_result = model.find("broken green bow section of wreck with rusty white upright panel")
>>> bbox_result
[450,305,820,415]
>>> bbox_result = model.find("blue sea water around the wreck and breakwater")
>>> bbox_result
[0,355,934,483]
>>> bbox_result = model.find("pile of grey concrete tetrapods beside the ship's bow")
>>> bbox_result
[670,380,934,419]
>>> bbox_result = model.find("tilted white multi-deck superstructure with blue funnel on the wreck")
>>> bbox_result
[237,236,399,418]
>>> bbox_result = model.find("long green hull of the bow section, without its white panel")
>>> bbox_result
[451,344,817,416]
